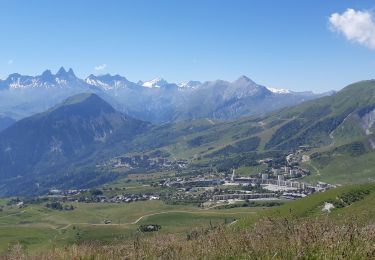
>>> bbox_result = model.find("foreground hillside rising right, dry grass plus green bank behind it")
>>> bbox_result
[6,184,375,259]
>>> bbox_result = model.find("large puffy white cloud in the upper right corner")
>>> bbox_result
[329,9,375,49]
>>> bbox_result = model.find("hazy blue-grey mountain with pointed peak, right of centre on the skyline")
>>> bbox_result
[175,76,324,120]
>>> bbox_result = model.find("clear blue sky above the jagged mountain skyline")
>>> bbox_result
[0,0,375,92]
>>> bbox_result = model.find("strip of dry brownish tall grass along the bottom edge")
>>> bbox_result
[2,219,375,260]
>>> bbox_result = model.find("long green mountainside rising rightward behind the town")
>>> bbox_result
[131,80,375,158]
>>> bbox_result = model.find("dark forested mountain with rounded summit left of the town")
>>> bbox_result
[0,93,148,196]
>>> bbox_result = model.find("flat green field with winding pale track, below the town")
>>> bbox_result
[0,201,258,252]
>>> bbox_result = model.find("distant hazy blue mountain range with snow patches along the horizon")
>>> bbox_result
[0,67,332,123]
